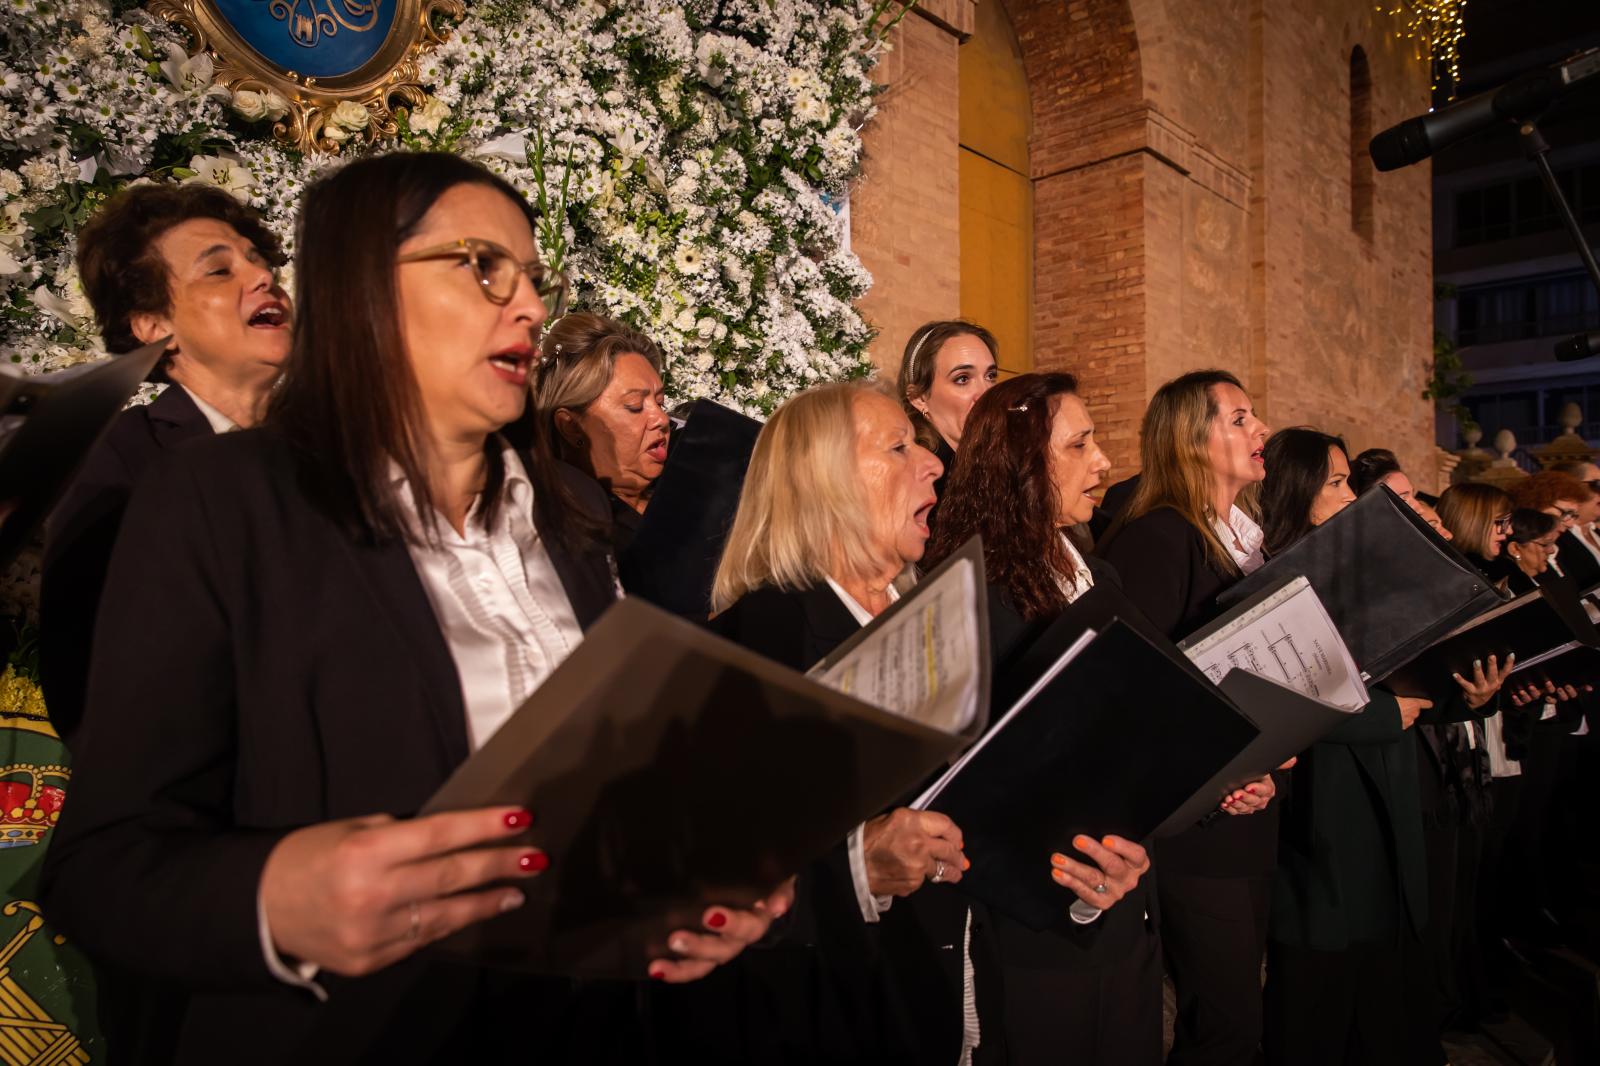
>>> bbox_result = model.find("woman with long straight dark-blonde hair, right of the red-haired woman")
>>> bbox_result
[1099,370,1277,1066]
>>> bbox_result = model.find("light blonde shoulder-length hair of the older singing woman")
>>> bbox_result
[710,381,883,613]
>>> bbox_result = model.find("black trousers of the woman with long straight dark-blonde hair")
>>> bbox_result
[1155,869,1272,1066]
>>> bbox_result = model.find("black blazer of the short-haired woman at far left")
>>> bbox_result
[38,384,213,747]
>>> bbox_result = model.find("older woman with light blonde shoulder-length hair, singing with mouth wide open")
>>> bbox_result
[712,383,981,1063]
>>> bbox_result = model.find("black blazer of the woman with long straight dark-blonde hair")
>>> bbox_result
[1096,507,1278,877]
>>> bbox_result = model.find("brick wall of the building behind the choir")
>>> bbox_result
[853,0,1435,487]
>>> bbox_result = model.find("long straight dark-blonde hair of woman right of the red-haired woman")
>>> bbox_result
[1107,370,1259,575]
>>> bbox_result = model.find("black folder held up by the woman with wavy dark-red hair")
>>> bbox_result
[928,617,1258,930]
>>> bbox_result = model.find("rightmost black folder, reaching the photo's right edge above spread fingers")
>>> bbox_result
[1384,589,1600,696]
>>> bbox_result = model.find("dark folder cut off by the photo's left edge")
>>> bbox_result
[0,338,170,567]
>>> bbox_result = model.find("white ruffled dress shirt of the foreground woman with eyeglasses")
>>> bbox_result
[262,441,584,1000]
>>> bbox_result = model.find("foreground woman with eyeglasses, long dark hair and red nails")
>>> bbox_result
[43,154,787,1063]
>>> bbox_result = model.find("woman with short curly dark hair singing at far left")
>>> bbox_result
[40,186,291,746]
